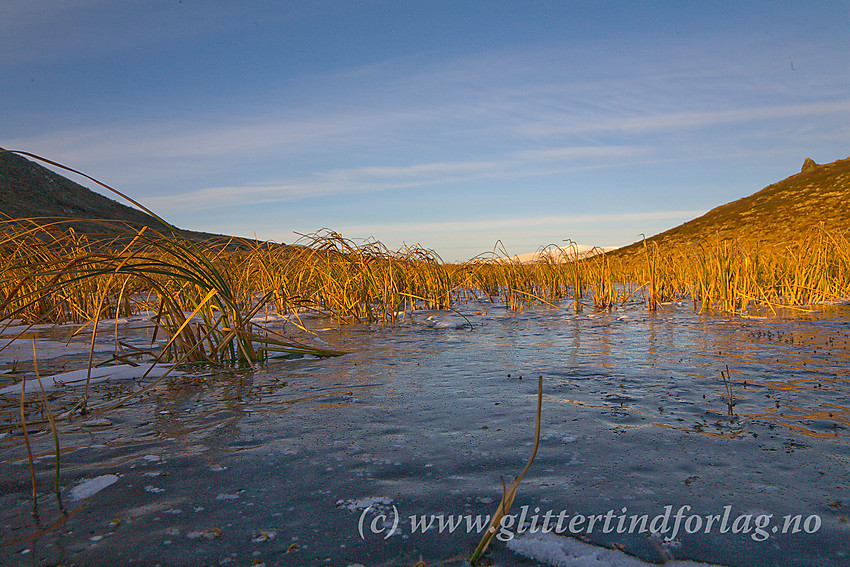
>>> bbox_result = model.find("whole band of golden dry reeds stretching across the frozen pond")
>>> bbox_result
[0,219,850,342]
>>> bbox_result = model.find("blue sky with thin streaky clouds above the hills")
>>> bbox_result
[0,0,850,261]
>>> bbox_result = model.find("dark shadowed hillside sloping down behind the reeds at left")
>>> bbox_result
[0,152,215,237]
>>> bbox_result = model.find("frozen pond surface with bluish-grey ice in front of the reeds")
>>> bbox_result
[0,303,850,567]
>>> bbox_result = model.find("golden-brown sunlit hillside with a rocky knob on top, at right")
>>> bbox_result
[612,158,850,256]
